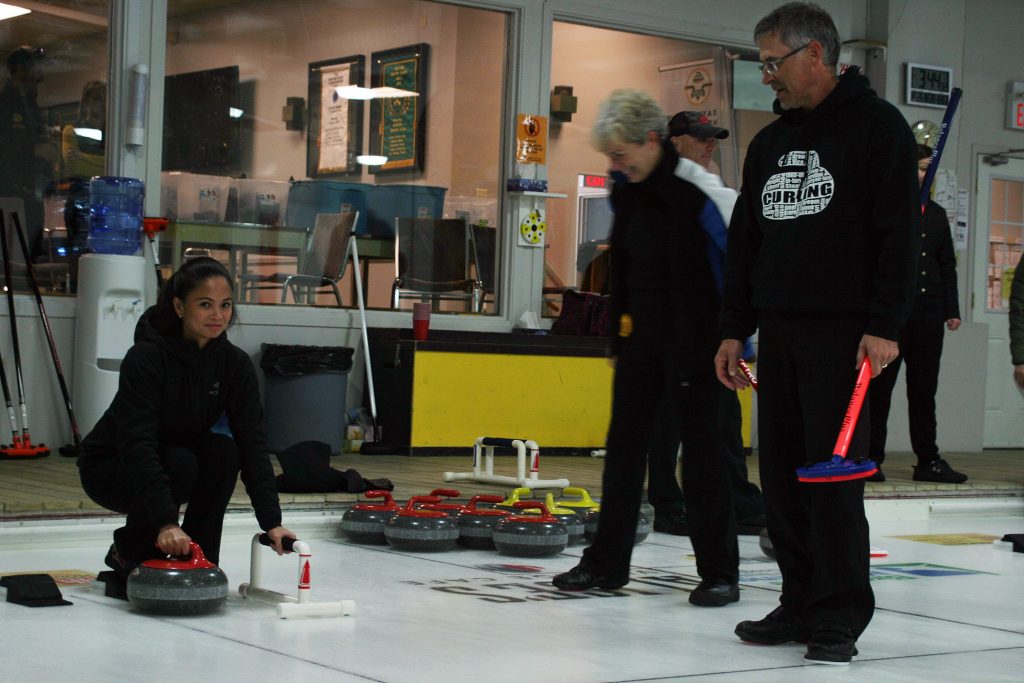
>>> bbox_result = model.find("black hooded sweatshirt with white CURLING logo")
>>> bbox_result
[722,70,921,340]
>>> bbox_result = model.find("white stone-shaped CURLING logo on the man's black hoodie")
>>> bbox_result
[761,151,836,220]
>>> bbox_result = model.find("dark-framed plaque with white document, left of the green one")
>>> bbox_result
[306,54,366,178]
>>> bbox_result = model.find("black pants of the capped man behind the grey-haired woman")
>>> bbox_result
[647,382,765,520]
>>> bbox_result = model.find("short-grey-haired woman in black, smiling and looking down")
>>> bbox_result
[552,90,739,606]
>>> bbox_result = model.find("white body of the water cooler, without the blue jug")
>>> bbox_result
[72,254,147,434]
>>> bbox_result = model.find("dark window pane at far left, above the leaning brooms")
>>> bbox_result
[0,0,109,293]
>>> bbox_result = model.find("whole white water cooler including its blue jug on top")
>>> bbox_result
[72,176,146,434]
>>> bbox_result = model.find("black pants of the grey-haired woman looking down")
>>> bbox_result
[583,339,739,583]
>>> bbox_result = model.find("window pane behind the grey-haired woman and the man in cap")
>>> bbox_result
[544,22,761,316]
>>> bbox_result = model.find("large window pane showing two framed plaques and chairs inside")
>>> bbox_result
[162,0,507,313]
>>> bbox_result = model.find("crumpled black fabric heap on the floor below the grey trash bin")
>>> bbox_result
[278,441,394,494]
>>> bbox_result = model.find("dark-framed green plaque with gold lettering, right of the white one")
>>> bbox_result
[370,43,430,173]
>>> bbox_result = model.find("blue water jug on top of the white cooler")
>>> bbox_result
[88,175,145,256]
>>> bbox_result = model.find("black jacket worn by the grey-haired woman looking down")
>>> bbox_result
[608,141,721,373]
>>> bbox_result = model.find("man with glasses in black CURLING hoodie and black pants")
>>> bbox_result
[715,2,921,664]
